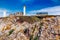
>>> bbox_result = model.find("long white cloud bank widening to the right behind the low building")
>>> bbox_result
[29,6,60,15]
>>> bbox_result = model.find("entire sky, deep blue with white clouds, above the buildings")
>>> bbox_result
[0,0,60,16]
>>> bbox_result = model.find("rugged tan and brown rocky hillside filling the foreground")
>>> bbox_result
[0,16,60,40]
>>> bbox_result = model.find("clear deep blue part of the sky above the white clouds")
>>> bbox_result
[0,0,60,14]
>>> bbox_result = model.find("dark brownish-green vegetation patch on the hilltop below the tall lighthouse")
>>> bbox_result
[17,16,40,23]
